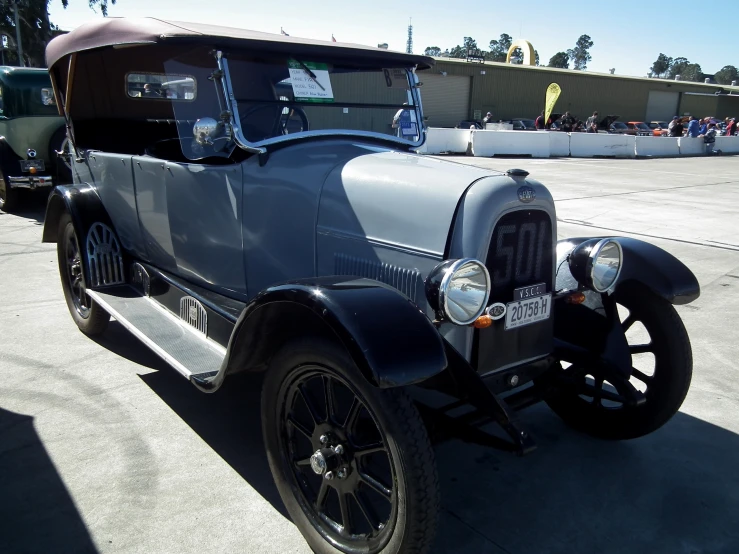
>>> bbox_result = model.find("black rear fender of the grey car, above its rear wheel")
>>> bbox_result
[41,183,118,283]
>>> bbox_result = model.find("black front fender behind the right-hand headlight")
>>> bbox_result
[556,237,700,305]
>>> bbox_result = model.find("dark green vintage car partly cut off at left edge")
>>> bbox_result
[0,66,70,212]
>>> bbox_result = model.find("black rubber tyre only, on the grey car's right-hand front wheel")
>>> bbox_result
[547,283,693,440]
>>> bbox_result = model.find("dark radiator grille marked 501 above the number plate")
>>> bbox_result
[485,210,554,303]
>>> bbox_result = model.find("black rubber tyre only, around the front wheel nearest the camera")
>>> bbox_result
[262,338,439,554]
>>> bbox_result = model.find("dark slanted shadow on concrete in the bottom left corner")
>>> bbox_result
[0,408,97,554]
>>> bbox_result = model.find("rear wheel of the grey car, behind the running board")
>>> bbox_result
[57,214,110,335]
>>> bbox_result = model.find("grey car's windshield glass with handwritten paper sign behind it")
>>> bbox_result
[229,56,420,143]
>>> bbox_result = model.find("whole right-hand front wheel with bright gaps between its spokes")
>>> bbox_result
[547,283,693,440]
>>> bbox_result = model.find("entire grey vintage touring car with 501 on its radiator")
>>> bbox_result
[43,18,699,553]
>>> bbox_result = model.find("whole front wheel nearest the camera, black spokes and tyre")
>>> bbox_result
[262,339,438,554]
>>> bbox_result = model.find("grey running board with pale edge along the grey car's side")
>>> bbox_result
[87,285,226,383]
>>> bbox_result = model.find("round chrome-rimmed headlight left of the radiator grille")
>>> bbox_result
[426,258,490,325]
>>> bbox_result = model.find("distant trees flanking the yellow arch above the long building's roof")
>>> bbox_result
[424,33,593,70]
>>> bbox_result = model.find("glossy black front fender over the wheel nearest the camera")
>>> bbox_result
[193,276,447,392]
